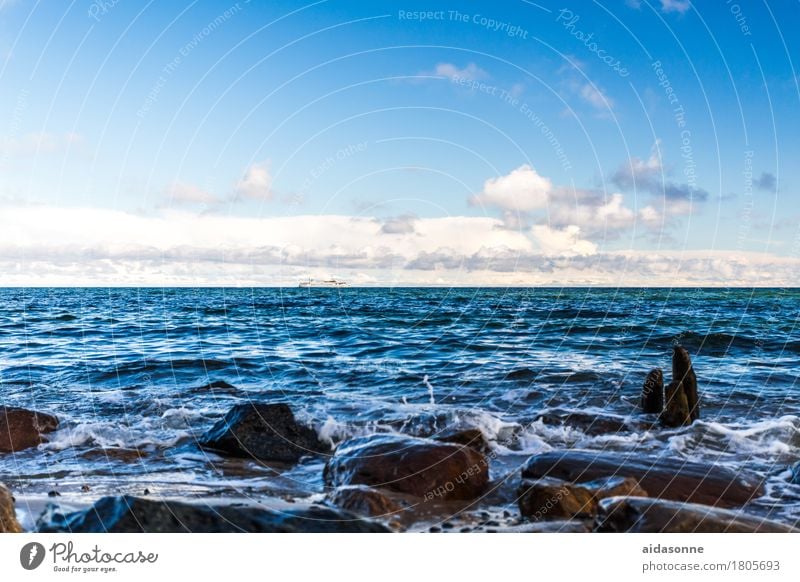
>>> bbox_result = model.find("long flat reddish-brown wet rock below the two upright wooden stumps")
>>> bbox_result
[522,451,764,507]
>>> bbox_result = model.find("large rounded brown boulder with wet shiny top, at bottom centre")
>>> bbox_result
[324,435,489,501]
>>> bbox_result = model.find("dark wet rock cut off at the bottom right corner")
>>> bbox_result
[595,497,800,533]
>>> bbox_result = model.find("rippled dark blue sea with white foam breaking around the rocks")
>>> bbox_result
[0,289,800,518]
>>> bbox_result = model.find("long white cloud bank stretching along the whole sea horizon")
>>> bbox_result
[0,204,800,286]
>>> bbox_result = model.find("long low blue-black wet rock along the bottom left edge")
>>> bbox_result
[37,496,389,533]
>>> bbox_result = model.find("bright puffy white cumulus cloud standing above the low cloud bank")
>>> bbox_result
[470,164,553,212]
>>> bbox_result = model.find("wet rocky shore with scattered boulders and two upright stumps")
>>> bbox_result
[0,347,800,533]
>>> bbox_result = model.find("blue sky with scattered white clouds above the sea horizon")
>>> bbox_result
[0,0,800,287]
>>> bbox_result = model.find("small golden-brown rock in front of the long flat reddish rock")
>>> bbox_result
[517,477,647,521]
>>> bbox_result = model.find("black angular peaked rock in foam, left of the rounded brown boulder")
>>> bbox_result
[199,403,330,463]
